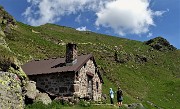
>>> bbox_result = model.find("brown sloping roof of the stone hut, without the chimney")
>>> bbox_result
[22,54,93,75]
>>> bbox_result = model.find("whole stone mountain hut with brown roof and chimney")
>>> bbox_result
[22,43,103,101]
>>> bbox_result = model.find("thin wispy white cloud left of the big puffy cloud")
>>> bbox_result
[22,0,108,26]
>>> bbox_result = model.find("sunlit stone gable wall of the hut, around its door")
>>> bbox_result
[75,60,102,101]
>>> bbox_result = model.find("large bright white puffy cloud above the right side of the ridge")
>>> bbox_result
[96,0,164,36]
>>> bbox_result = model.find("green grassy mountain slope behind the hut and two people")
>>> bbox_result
[1,23,180,109]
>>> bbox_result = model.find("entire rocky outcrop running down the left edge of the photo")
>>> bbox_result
[0,7,27,109]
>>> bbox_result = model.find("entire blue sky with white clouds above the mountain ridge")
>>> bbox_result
[0,0,180,49]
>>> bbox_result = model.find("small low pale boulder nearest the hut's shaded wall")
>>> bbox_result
[35,93,52,105]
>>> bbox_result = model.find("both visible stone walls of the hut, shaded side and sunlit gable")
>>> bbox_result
[30,59,102,101]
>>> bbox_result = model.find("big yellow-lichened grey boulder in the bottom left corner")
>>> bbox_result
[0,71,24,109]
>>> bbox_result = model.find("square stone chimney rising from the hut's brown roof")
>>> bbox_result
[66,43,78,66]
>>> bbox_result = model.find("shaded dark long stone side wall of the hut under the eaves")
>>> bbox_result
[30,72,74,96]
